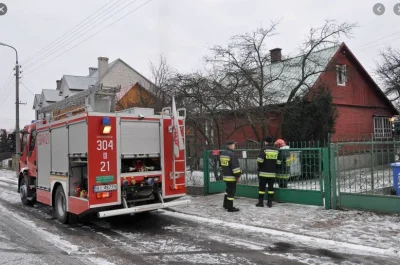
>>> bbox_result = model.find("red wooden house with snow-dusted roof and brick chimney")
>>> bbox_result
[198,43,399,143]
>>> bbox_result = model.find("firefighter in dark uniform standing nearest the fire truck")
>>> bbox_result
[219,141,242,212]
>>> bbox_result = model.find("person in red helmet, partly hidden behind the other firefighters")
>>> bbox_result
[275,139,290,188]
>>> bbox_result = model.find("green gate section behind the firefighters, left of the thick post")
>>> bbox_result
[203,148,331,209]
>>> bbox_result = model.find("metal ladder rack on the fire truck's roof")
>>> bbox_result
[38,84,121,118]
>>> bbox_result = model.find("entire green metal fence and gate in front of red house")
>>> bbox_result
[203,141,400,213]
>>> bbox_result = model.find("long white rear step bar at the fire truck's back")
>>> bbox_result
[97,200,190,218]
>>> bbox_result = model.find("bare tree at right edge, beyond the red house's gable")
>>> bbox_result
[376,47,400,104]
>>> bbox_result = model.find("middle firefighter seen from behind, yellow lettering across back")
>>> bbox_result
[256,136,278,207]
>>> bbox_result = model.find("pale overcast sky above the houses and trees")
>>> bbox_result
[0,0,400,129]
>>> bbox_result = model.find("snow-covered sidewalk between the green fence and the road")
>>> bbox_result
[173,194,400,255]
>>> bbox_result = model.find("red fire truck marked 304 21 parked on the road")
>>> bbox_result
[18,85,190,223]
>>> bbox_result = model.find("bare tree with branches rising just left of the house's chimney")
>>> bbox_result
[207,22,284,141]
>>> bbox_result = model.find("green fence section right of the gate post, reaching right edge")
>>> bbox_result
[330,141,400,213]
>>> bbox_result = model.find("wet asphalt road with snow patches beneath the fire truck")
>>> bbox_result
[0,177,398,265]
